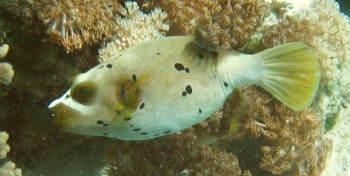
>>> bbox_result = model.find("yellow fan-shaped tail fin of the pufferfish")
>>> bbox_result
[257,42,321,111]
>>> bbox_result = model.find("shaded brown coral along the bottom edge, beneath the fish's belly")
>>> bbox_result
[107,129,248,176]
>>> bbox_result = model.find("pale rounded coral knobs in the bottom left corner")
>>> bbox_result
[0,131,22,176]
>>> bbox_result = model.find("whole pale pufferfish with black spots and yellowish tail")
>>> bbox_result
[49,36,320,140]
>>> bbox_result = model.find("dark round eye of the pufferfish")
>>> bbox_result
[71,82,96,104]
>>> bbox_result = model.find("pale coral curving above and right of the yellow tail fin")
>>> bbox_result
[262,0,350,124]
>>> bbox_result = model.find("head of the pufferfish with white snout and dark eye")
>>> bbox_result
[49,73,117,136]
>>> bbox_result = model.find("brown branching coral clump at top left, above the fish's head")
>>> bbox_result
[33,0,122,52]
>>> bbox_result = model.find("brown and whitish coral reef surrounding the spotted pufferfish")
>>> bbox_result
[0,0,350,175]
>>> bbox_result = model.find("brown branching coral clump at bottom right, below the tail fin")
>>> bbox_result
[260,111,332,176]
